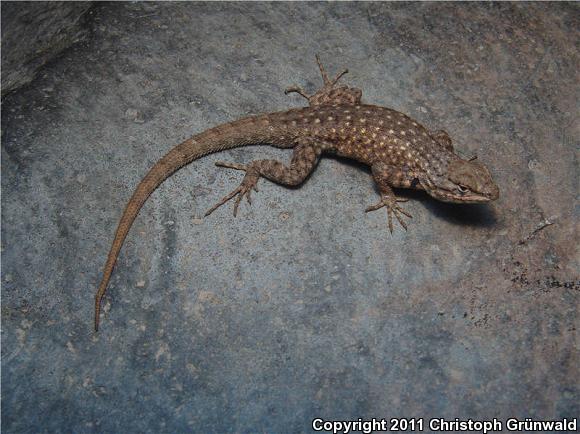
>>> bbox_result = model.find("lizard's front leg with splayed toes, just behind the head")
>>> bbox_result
[365,163,414,233]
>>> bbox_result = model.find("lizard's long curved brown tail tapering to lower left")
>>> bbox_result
[95,115,276,331]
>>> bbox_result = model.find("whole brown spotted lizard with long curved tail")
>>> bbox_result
[94,55,499,331]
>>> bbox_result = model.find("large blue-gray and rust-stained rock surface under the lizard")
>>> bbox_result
[1,3,580,433]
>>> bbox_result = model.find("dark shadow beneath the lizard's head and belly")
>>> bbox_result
[329,155,498,231]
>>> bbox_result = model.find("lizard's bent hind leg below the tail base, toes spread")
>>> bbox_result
[205,139,321,217]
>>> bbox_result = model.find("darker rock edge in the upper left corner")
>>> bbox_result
[1,1,93,96]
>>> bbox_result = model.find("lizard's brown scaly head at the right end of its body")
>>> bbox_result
[422,156,499,203]
